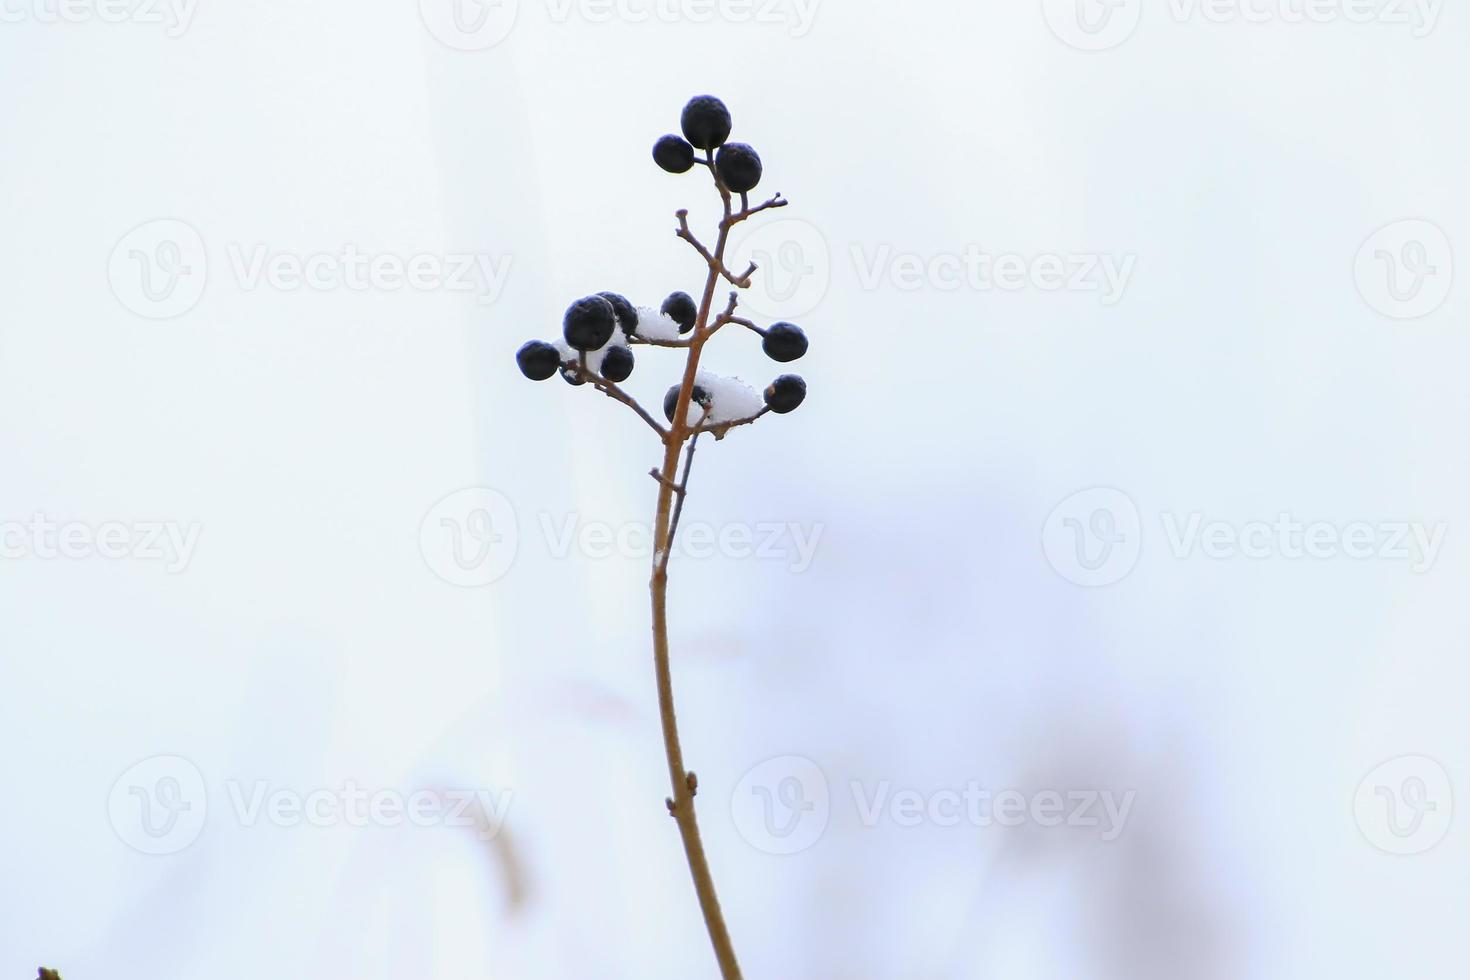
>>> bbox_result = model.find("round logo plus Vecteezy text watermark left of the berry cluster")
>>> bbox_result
[107,217,512,320]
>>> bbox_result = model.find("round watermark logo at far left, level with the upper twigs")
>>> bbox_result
[107,217,209,320]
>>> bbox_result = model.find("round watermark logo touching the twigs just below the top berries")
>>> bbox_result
[726,217,832,317]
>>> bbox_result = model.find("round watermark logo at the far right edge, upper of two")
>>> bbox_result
[1352,219,1455,320]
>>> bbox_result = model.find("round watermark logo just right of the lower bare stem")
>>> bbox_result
[731,755,832,855]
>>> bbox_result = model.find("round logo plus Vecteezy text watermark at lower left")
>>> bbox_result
[107,755,512,854]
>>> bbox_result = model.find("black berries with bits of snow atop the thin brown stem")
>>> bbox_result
[516,96,807,428]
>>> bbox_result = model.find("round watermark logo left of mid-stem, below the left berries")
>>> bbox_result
[419,486,520,589]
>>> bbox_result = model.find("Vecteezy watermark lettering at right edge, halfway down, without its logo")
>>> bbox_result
[1163,513,1449,574]
